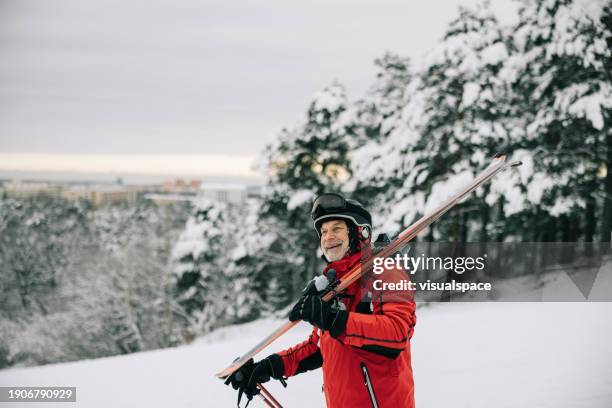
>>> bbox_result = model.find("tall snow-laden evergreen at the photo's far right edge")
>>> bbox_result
[508,0,612,242]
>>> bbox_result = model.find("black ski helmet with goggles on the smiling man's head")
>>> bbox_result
[310,193,372,252]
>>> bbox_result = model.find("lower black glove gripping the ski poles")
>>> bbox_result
[225,354,286,406]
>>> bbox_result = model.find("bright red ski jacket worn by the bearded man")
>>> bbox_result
[278,253,416,408]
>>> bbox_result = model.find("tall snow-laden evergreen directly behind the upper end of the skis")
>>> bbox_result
[408,4,512,242]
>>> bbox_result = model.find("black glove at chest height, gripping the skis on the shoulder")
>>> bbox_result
[289,296,348,337]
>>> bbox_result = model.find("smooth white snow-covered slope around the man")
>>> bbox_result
[0,302,612,408]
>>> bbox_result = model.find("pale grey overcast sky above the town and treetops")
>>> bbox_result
[0,0,516,178]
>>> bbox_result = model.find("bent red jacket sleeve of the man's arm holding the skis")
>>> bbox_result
[338,271,416,358]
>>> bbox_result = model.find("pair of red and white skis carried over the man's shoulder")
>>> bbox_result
[215,154,521,407]
